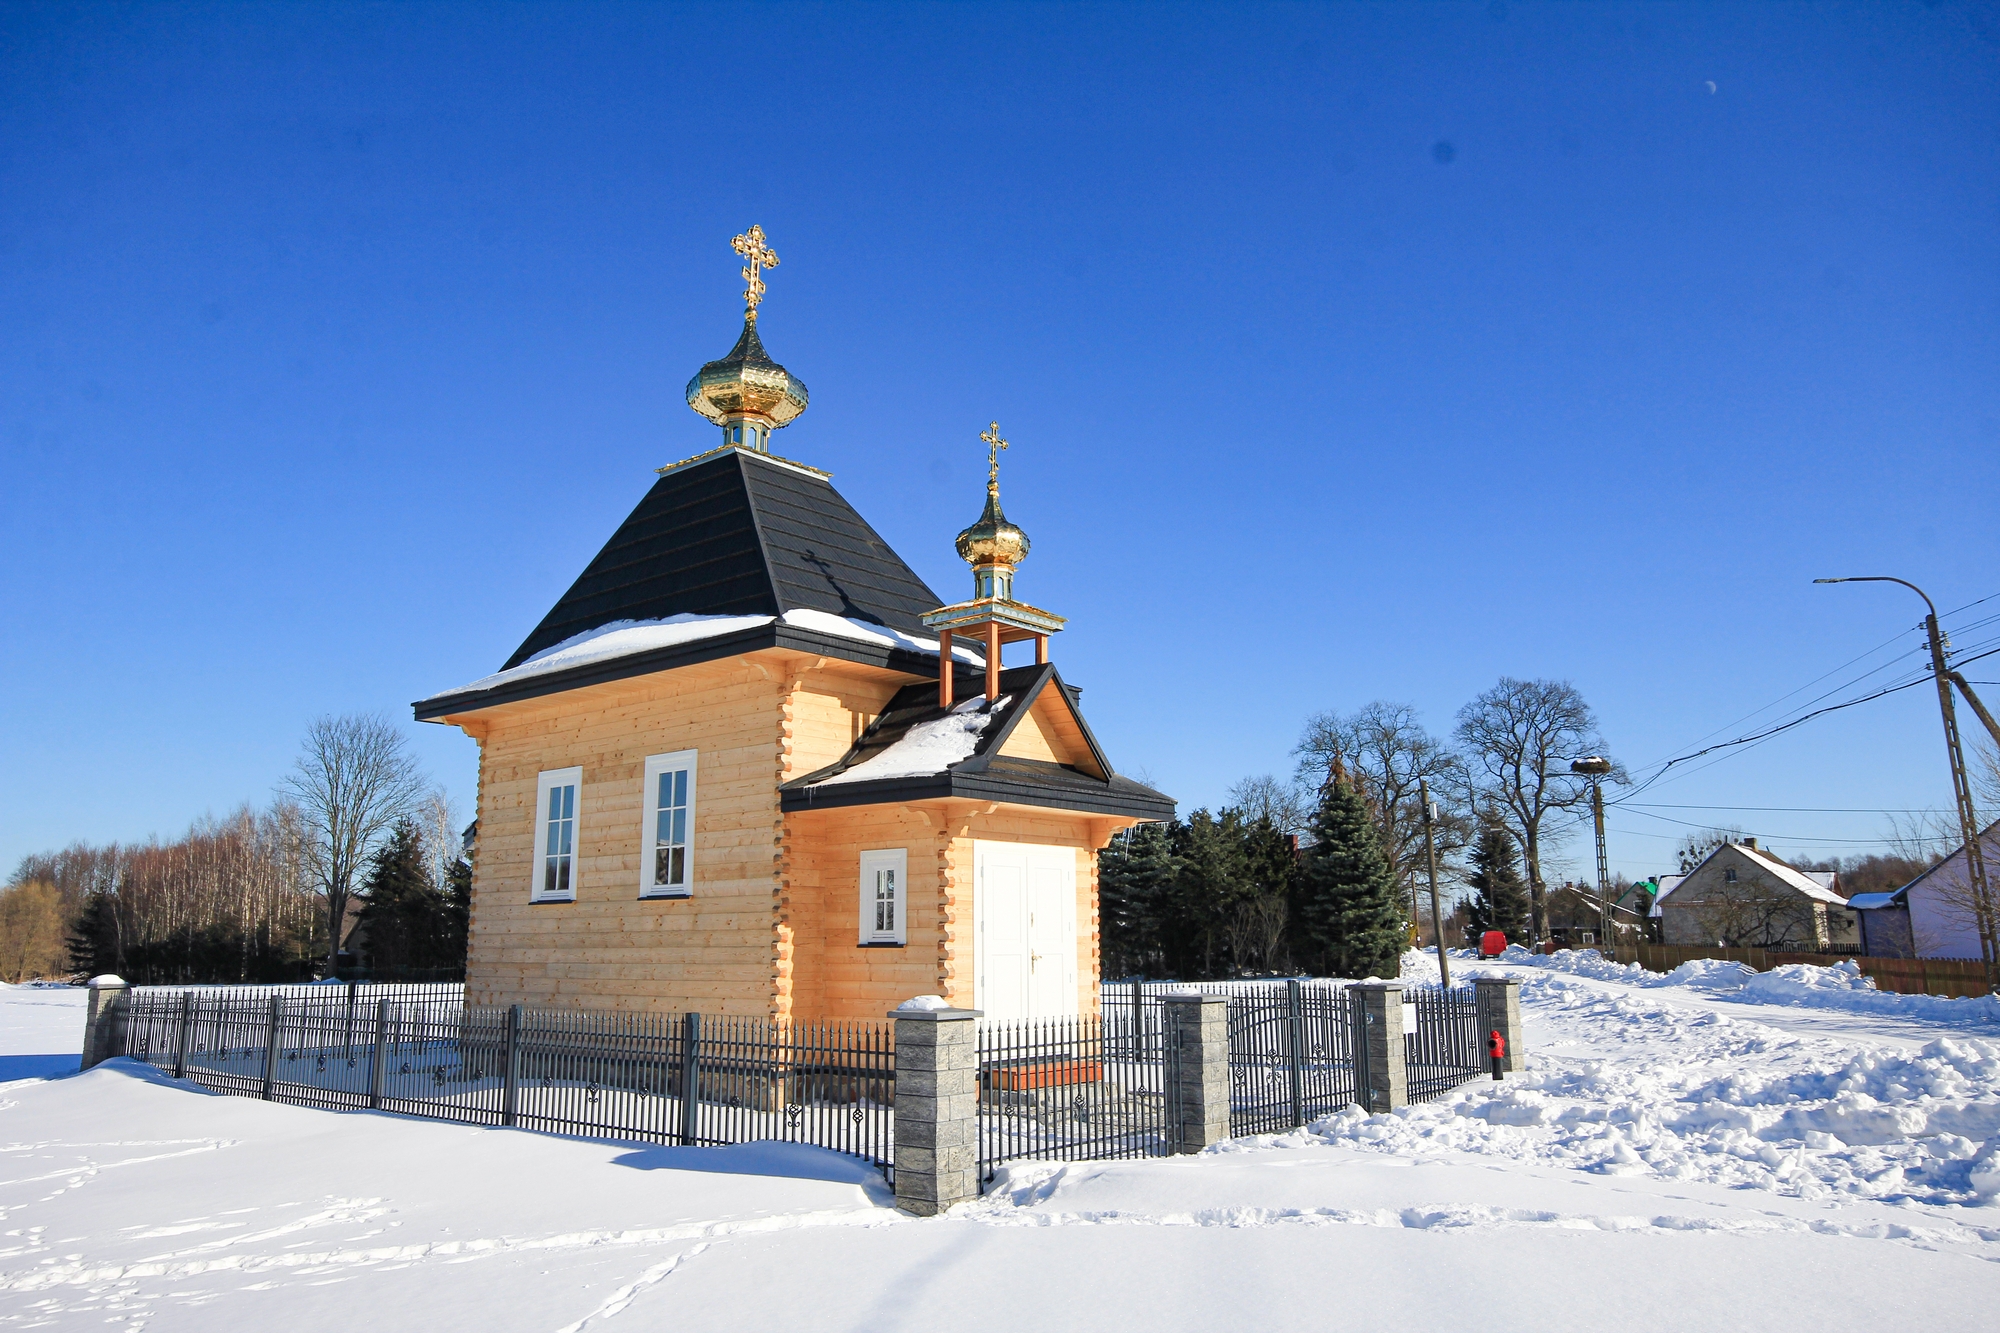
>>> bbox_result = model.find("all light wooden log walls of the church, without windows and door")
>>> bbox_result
[450,650,1134,1021]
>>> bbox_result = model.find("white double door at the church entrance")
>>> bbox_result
[972,841,1078,1019]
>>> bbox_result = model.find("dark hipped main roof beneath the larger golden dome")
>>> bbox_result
[502,450,942,671]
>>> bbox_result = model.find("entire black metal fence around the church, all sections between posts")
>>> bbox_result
[109,981,1486,1179]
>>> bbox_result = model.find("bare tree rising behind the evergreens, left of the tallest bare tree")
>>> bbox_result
[1292,699,1472,888]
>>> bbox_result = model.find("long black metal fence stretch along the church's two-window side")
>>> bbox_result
[126,985,896,1167]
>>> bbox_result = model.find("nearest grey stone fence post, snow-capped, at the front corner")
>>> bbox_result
[888,1009,980,1217]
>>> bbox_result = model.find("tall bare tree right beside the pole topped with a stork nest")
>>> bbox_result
[1458,677,1630,945]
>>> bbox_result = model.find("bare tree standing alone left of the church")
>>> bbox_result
[284,715,426,977]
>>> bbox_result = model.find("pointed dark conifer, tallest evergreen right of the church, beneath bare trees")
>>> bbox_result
[1294,765,1410,977]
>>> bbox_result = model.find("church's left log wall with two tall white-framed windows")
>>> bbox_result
[466,658,786,1017]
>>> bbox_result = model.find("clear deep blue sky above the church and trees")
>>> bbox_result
[0,2,2000,875]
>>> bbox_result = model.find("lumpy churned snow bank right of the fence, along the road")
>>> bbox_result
[1272,953,2000,1205]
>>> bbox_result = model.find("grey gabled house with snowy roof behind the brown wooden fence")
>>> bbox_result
[1656,839,1860,953]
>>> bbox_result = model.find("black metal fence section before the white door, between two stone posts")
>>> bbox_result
[978,1003,1178,1181]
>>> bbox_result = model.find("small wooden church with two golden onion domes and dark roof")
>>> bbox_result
[414,226,1174,1021]
